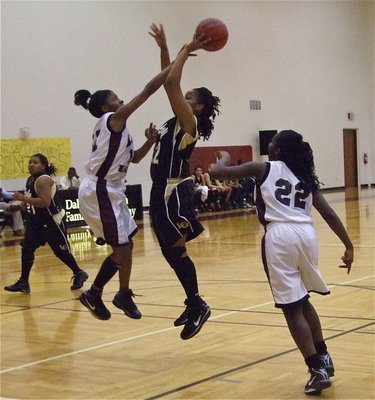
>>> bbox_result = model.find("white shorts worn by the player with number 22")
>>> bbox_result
[264,223,329,307]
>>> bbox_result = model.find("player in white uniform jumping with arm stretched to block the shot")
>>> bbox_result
[74,53,170,320]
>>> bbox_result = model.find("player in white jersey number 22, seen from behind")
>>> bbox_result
[212,130,354,395]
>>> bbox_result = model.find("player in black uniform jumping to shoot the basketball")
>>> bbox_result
[150,24,220,340]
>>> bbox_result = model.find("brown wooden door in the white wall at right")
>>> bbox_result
[343,129,358,188]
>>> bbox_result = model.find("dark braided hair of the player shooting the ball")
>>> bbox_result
[193,87,220,140]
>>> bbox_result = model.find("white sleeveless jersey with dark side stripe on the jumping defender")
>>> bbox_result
[85,112,134,181]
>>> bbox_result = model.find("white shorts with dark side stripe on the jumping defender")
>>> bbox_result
[78,176,137,246]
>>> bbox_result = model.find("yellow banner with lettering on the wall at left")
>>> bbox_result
[0,137,71,179]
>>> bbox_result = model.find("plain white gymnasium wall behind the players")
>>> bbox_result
[1,1,375,205]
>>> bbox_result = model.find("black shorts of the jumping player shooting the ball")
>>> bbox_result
[150,179,204,248]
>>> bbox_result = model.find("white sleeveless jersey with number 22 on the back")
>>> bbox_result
[256,161,313,226]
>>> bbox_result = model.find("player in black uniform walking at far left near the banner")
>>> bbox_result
[4,153,89,293]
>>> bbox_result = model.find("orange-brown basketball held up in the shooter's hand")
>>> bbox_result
[195,18,228,51]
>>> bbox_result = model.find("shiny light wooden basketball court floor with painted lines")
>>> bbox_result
[0,189,375,400]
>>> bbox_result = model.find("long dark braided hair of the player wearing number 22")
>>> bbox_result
[274,130,321,192]
